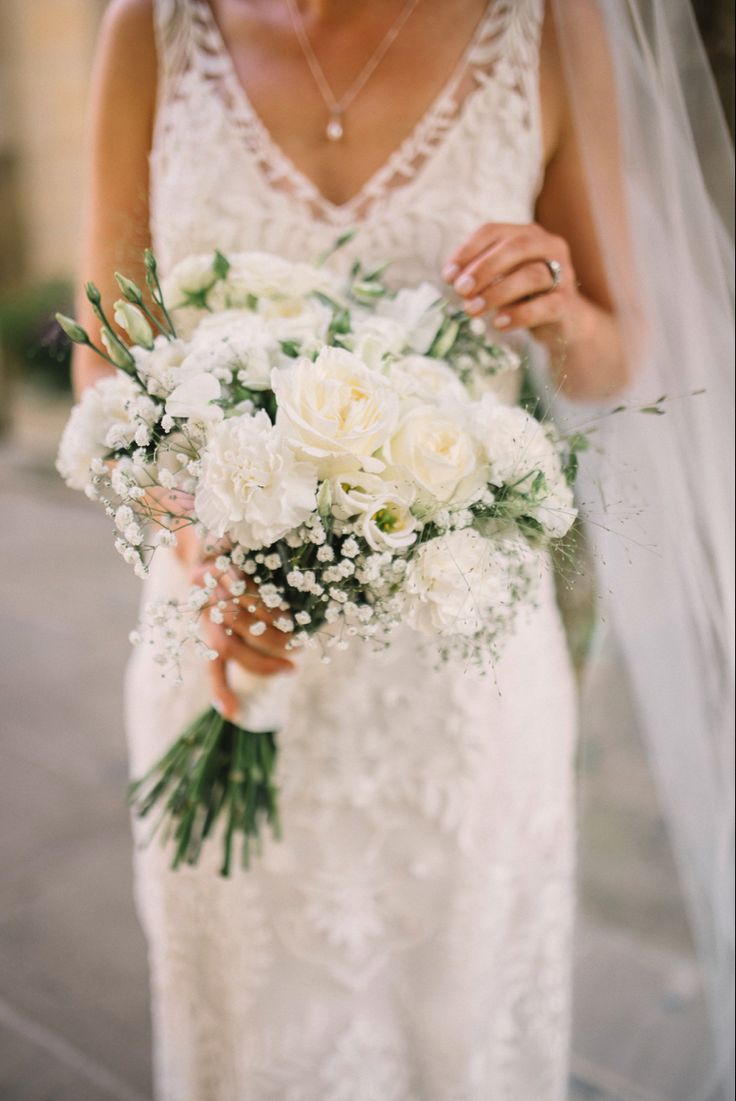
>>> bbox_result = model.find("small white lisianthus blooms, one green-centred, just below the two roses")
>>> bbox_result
[331,475,419,552]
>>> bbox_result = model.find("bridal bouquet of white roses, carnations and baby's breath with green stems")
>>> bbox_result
[58,245,583,874]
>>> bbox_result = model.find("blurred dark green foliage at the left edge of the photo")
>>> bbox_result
[0,280,74,391]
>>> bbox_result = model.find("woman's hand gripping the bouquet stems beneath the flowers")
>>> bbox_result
[192,562,294,721]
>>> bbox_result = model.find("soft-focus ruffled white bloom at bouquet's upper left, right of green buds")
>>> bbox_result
[180,309,282,390]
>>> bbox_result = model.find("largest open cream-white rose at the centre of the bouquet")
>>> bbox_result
[271,348,399,477]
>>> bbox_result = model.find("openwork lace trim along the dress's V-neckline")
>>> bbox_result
[196,0,506,221]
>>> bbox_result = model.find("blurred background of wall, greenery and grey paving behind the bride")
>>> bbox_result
[0,0,734,1101]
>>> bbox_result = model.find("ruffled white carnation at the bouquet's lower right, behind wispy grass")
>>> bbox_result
[405,527,510,635]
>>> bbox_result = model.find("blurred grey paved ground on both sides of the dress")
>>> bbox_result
[0,389,705,1101]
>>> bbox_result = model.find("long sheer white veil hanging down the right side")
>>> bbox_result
[551,0,734,1101]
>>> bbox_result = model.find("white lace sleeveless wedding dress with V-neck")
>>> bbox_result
[127,0,575,1101]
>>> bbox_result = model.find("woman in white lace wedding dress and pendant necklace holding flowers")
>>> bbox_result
[75,0,731,1101]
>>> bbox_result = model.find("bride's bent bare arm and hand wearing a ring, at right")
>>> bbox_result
[444,0,629,400]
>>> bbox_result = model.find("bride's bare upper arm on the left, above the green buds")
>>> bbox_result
[73,0,156,395]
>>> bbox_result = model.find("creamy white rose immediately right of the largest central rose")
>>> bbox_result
[383,405,486,506]
